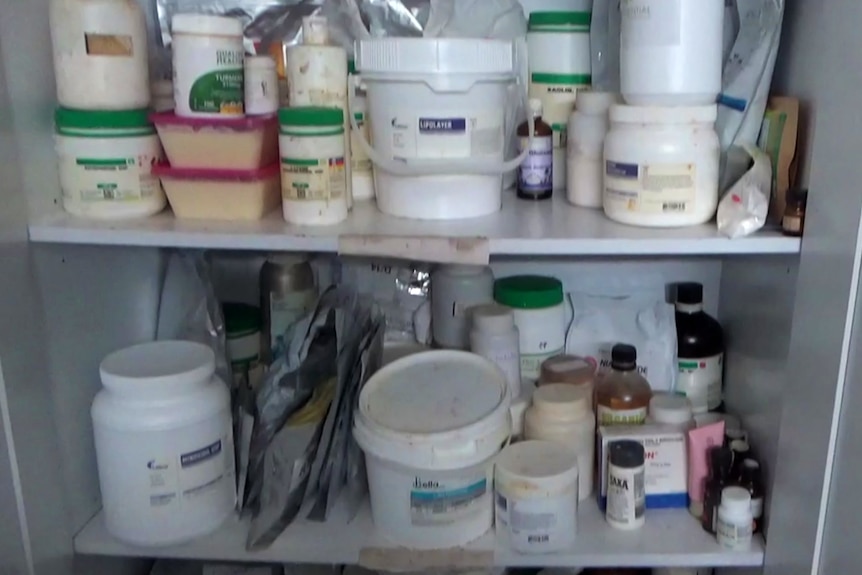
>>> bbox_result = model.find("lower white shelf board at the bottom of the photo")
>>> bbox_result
[75,500,763,571]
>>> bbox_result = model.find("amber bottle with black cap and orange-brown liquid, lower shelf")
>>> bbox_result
[596,343,652,425]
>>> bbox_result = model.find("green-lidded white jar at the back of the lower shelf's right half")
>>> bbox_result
[494,275,566,381]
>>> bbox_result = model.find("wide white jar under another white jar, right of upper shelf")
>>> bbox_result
[603,105,720,227]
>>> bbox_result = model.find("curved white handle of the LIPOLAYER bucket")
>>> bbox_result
[347,79,535,176]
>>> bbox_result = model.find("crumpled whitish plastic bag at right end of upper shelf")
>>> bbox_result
[716,144,772,239]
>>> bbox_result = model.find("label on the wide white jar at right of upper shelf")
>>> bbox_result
[605,160,697,214]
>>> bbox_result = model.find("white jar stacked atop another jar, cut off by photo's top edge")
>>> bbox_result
[620,0,725,106]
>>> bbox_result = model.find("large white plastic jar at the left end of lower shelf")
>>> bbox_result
[91,341,236,546]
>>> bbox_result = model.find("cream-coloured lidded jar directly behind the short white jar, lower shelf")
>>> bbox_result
[524,383,596,501]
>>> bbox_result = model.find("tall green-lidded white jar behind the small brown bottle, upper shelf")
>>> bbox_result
[527,12,592,190]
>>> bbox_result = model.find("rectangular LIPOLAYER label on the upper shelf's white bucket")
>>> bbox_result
[389,111,504,159]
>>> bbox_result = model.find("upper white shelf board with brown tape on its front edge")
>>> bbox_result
[30,192,800,263]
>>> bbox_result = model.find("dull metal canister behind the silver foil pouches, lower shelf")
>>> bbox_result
[260,254,317,365]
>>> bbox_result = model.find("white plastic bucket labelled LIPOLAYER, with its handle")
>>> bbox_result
[349,38,532,220]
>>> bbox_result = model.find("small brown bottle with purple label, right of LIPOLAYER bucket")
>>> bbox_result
[518,98,554,200]
